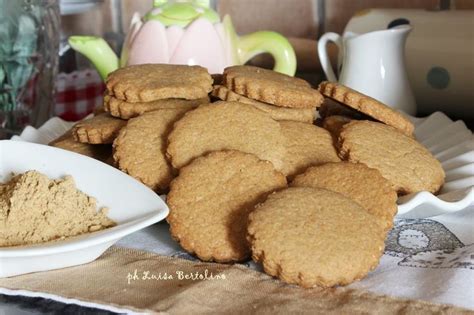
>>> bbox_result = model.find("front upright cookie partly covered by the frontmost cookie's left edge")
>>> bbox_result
[167,151,286,262]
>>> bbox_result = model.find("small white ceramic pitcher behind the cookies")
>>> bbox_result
[318,25,416,115]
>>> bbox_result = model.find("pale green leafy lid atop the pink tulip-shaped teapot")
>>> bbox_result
[143,0,220,27]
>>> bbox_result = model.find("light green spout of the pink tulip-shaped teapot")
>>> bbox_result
[68,36,119,80]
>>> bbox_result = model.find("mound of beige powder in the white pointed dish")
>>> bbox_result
[0,171,116,247]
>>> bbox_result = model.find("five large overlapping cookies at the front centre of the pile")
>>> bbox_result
[162,95,397,287]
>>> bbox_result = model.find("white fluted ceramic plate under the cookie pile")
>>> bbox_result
[14,112,474,218]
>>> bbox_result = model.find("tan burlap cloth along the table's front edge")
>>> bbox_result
[0,247,474,314]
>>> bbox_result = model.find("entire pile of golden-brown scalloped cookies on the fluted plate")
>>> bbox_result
[50,64,444,287]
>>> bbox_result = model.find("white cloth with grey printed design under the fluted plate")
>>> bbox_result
[113,209,474,310]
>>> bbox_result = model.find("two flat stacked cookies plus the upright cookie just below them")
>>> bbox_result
[104,64,212,192]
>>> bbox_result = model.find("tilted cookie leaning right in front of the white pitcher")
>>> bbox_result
[318,81,415,136]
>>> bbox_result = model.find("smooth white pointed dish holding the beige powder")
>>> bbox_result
[0,140,169,277]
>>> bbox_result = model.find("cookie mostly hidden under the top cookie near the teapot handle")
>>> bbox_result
[211,85,316,123]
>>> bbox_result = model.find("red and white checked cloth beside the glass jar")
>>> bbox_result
[54,69,105,121]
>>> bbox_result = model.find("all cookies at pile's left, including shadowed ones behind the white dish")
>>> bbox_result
[51,64,212,192]
